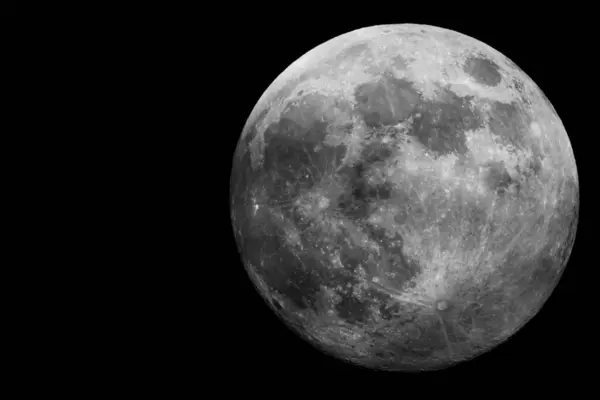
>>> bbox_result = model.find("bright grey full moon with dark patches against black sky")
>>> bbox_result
[230,24,579,370]
